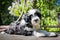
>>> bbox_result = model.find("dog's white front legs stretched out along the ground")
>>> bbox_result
[33,30,58,37]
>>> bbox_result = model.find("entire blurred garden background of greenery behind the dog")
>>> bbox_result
[0,0,60,32]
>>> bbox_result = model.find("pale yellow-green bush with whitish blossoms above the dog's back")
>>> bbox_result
[8,0,32,16]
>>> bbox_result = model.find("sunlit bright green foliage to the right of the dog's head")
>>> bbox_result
[33,0,58,28]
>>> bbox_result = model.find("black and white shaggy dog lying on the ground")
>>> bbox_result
[1,9,56,37]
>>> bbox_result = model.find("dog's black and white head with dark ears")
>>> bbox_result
[24,9,41,29]
